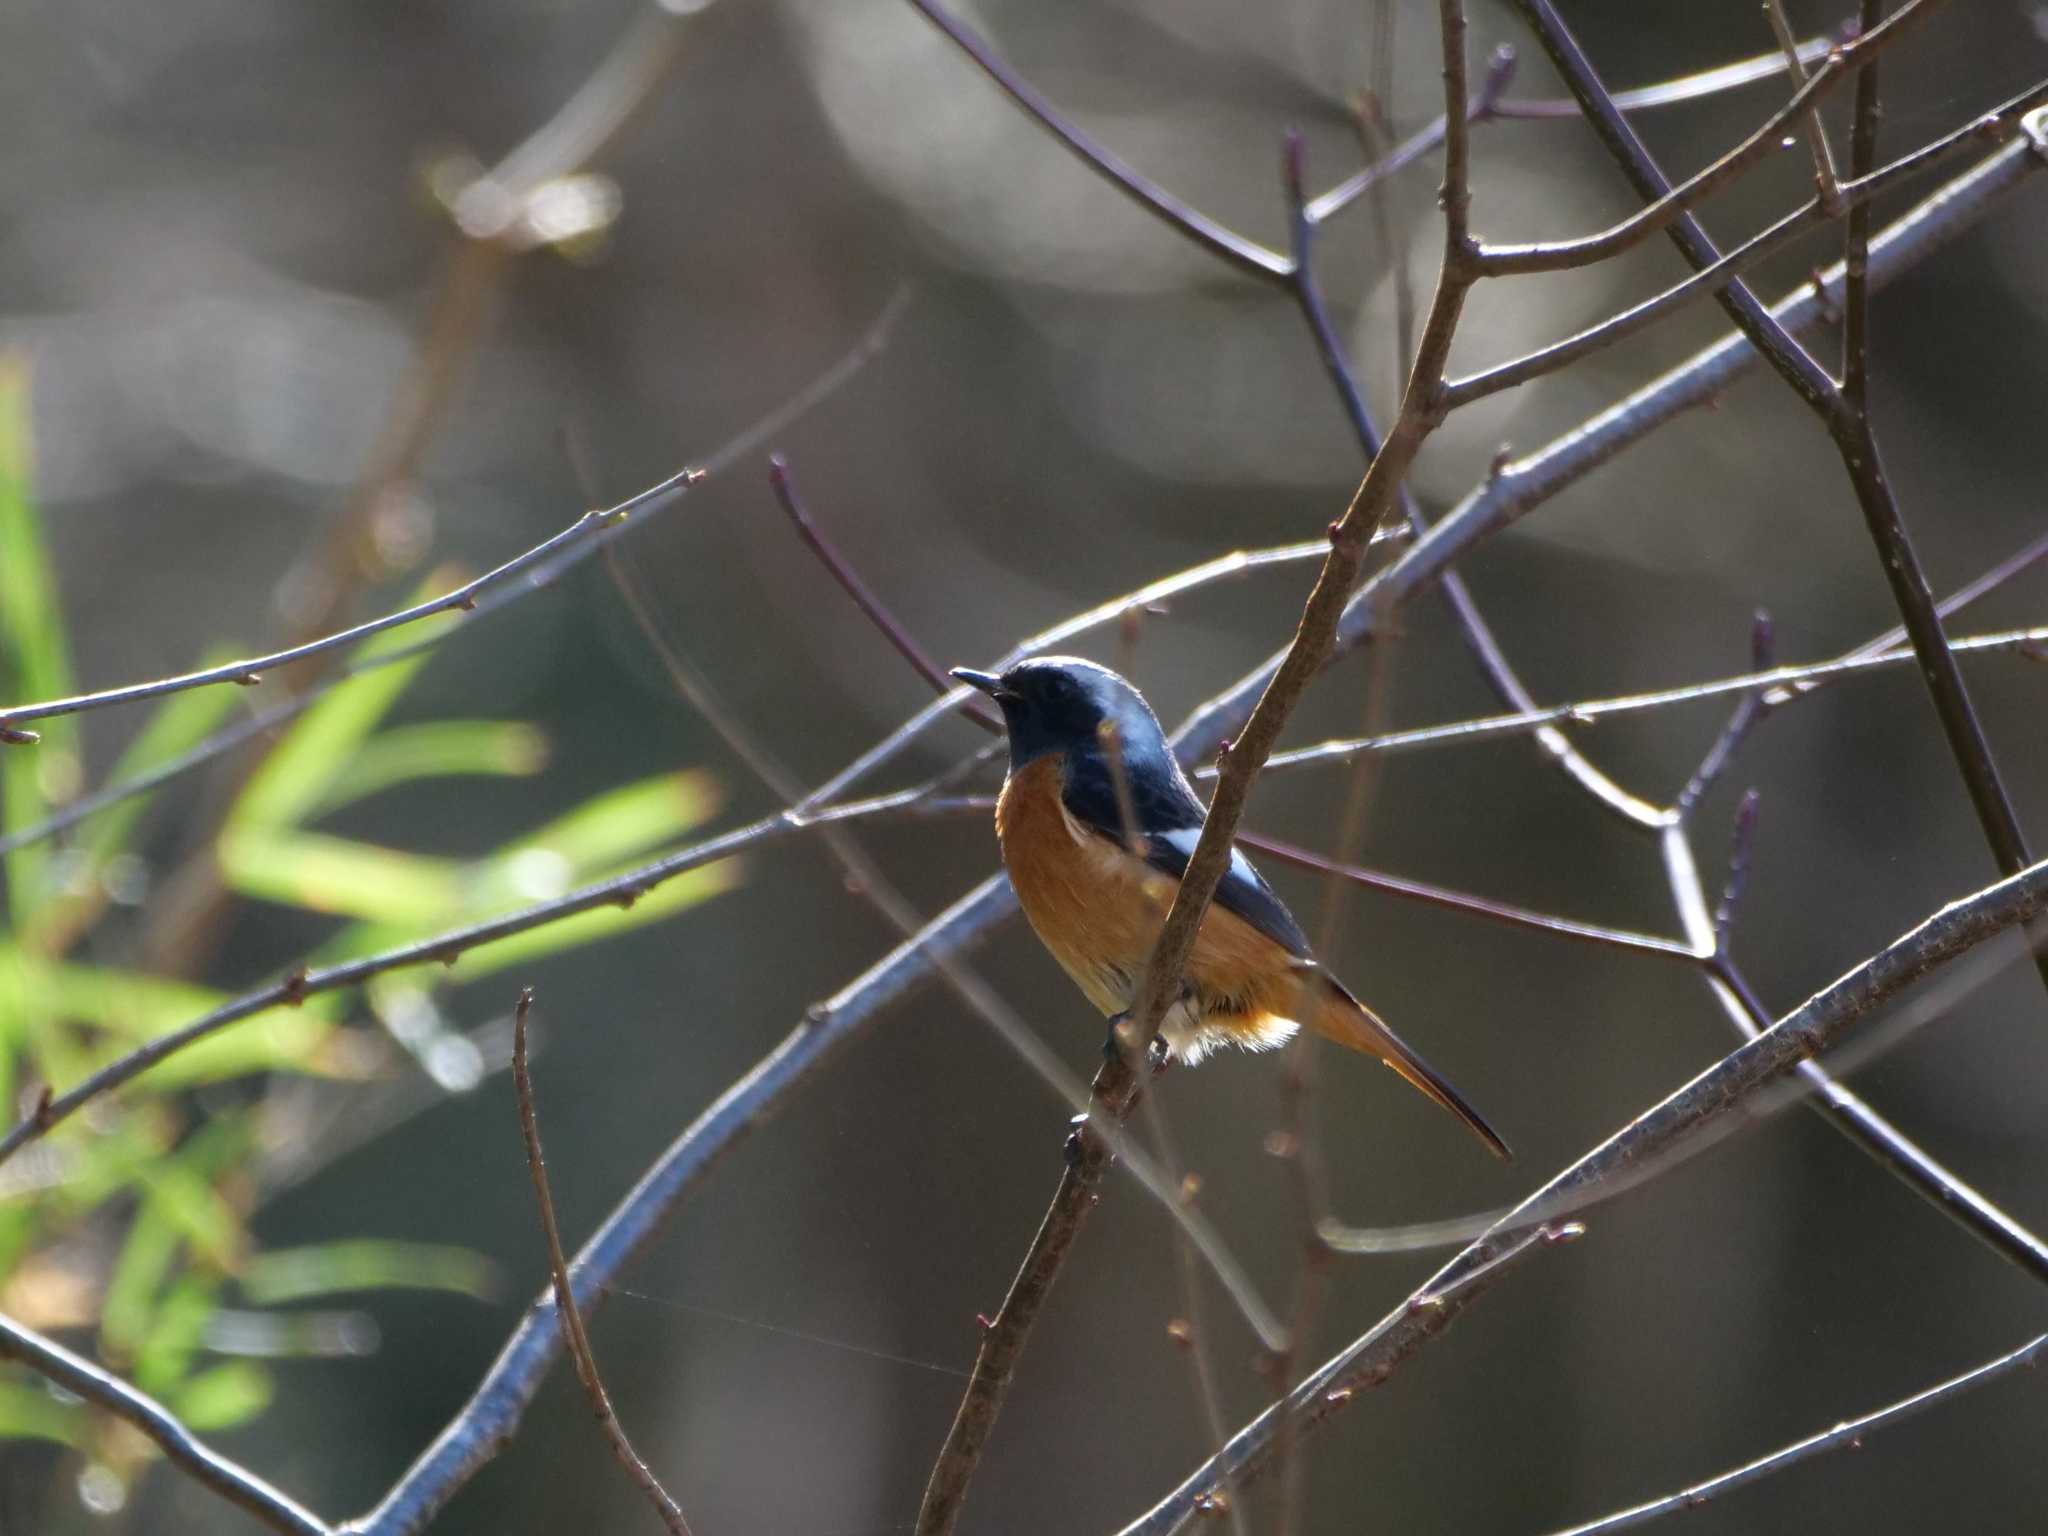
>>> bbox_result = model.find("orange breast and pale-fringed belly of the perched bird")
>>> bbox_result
[995,756,1300,1057]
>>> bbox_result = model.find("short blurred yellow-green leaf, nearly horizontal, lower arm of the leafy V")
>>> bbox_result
[215,825,465,928]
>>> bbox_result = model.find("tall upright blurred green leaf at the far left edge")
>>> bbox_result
[0,354,80,928]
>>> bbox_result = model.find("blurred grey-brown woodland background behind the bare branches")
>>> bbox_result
[0,0,2048,1536]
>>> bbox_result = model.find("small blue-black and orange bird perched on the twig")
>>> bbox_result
[952,655,1509,1157]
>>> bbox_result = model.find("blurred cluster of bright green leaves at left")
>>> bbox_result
[0,365,733,1501]
